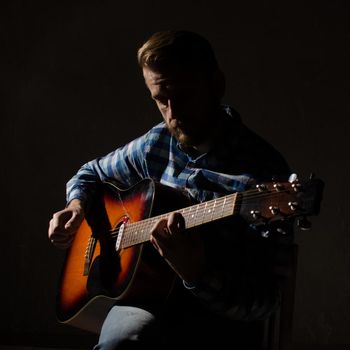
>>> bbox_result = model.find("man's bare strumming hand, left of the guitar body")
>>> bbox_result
[48,199,84,249]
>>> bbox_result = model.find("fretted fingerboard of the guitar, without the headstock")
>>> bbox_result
[117,193,237,249]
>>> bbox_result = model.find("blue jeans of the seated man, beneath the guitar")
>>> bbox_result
[94,304,262,350]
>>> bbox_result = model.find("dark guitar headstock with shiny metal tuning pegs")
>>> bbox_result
[240,174,324,236]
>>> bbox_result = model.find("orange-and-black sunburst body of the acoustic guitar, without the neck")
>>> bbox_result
[56,179,186,333]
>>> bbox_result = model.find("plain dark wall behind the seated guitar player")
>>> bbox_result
[0,0,350,349]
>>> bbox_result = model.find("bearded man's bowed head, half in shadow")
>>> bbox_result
[137,31,225,146]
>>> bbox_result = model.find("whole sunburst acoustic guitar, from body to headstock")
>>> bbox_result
[56,178,324,333]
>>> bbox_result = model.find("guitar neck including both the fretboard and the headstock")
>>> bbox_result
[113,175,324,250]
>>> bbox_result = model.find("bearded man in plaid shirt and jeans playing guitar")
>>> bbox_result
[49,31,291,350]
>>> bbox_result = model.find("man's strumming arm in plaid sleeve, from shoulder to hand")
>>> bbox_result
[48,131,149,249]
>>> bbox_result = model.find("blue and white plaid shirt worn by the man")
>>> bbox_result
[67,106,290,319]
